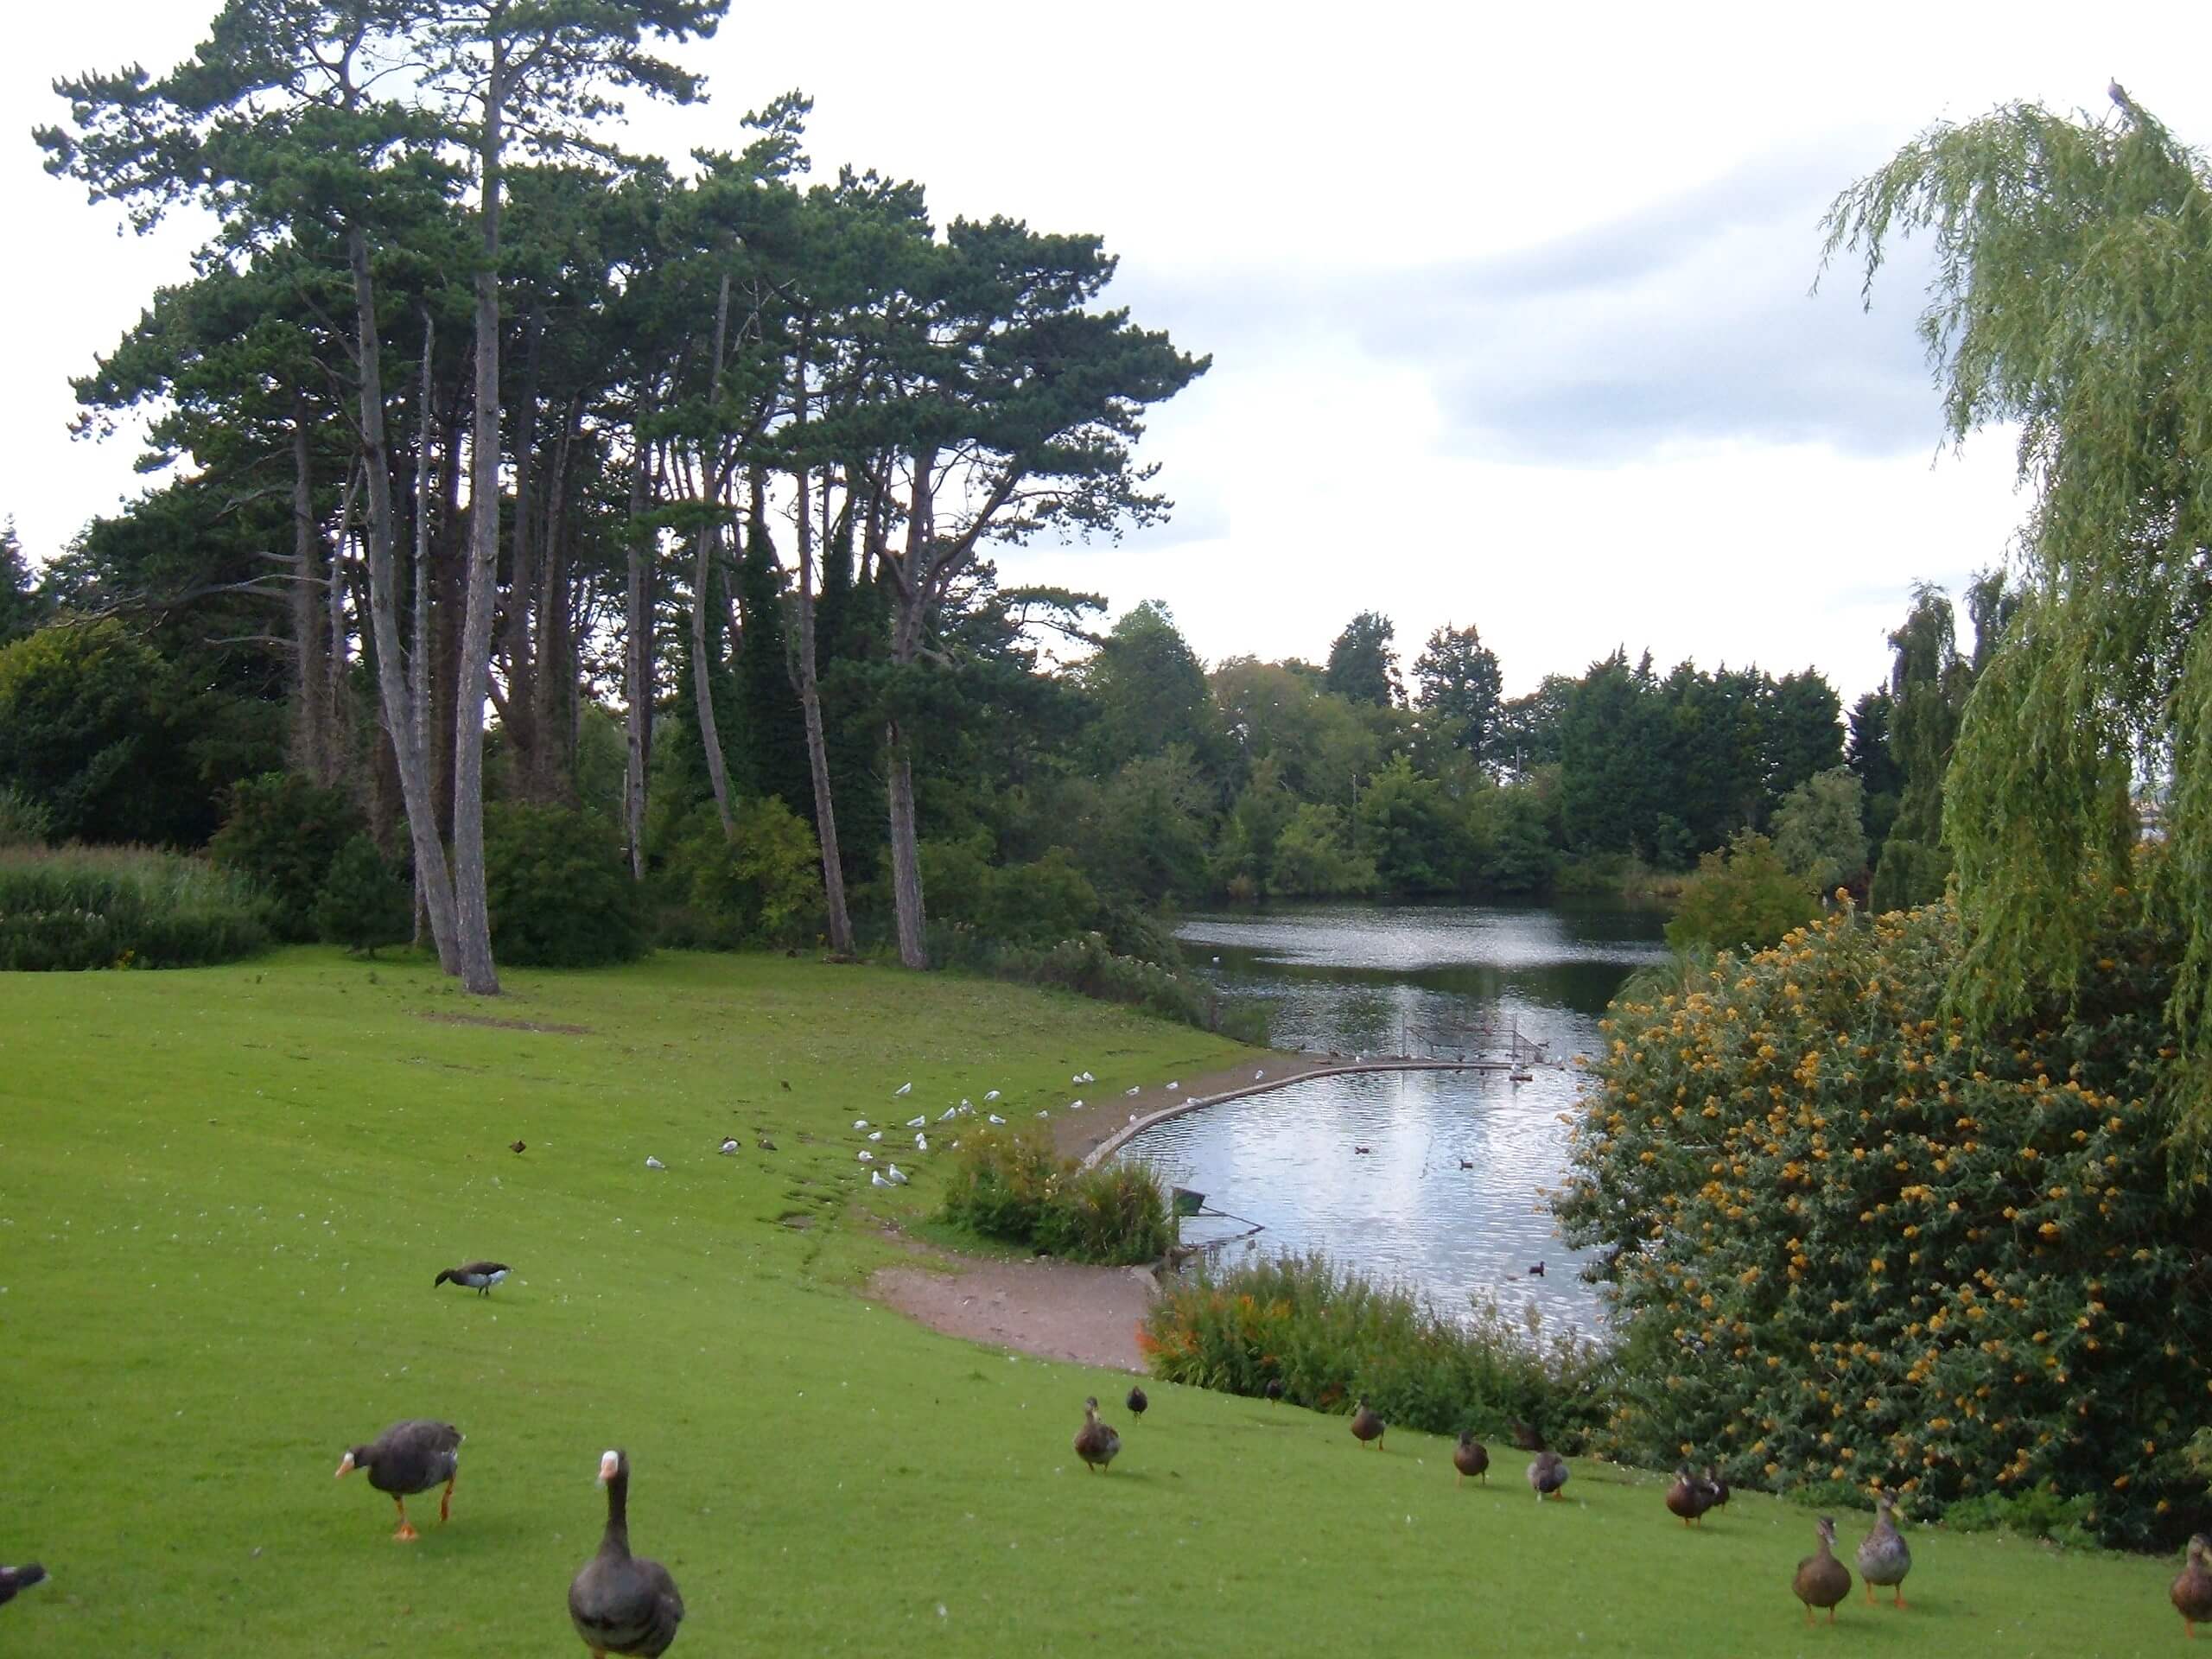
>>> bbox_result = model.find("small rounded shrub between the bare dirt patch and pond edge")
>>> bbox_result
[938,1128,1174,1265]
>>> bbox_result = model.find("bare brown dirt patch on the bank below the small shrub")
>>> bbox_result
[868,1252,1153,1371]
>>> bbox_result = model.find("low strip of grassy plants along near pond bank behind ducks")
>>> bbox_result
[1139,1255,1608,1451]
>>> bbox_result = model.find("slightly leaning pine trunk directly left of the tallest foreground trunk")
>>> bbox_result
[345,226,460,973]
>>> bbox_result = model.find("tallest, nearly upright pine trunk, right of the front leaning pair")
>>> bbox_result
[454,48,506,995]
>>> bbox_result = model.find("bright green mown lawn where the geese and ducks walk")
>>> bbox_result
[0,951,2181,1659]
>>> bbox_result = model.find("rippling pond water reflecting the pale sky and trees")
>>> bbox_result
[1122,905,1666,1332]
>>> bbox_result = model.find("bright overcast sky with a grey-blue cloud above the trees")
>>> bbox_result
[0,0,2212,702]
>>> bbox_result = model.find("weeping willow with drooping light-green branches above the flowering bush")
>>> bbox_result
[1825,84,2212,1128]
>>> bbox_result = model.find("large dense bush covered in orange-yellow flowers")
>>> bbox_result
[1560,907,2212,1544]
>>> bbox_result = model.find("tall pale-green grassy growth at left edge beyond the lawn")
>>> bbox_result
[0,847,270,973]
